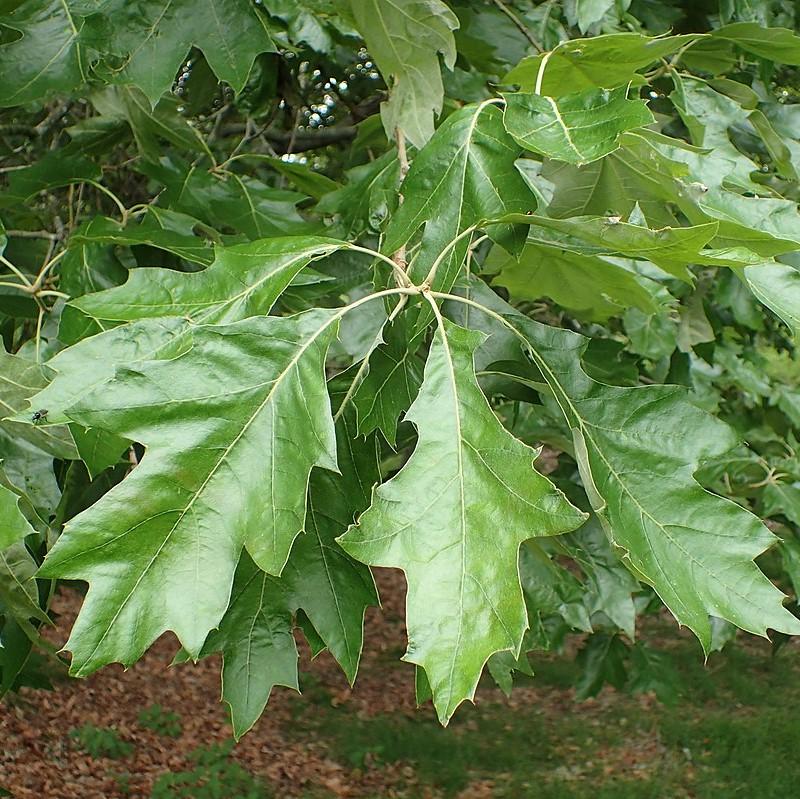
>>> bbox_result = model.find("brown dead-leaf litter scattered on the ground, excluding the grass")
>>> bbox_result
[0,569,692,799]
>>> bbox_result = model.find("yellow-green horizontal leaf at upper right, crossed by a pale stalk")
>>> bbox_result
[504,33,702,97]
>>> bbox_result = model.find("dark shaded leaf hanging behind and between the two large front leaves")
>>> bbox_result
[203,406,380,738]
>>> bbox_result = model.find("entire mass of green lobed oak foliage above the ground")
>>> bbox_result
[0,0,800,736]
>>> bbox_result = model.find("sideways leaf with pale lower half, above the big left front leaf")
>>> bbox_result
[24,237,343,432]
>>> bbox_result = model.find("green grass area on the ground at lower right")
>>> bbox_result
[287,639,800,799]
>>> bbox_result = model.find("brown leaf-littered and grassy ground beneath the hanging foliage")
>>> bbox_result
[0,571,800,799]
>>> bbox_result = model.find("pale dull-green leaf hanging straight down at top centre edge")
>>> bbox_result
[350,0,458,149]
